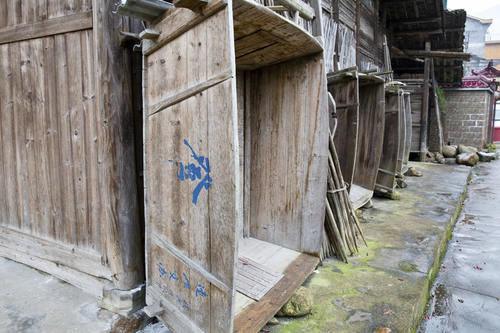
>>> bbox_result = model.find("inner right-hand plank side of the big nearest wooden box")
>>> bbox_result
[249,55,328,253]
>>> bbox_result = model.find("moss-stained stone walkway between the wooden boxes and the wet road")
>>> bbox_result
[265,163,471,333]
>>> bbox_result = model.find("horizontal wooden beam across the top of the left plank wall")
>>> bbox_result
[0,11,92,45]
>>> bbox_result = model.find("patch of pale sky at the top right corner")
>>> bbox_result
[448,0,500,40]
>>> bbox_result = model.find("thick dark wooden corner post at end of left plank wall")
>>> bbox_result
[91,0,144,290]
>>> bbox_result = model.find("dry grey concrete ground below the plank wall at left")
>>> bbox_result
[0,257,118,333]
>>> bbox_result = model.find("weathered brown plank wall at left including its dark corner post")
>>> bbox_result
[0,0,143,294]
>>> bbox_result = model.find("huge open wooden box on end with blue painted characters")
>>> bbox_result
[118,0,328,332]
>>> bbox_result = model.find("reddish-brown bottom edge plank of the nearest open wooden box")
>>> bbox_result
[234,253,319,333]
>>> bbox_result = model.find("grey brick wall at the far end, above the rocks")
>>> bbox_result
[443,89,492,147]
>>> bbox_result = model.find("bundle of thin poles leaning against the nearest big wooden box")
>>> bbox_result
[321,133,366,262]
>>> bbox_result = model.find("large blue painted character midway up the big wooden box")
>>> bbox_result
[169,139,212,205]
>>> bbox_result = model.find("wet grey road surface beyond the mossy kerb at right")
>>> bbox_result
[418,156,500,333]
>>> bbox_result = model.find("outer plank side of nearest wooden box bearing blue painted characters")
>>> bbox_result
[144,4,241,332]
